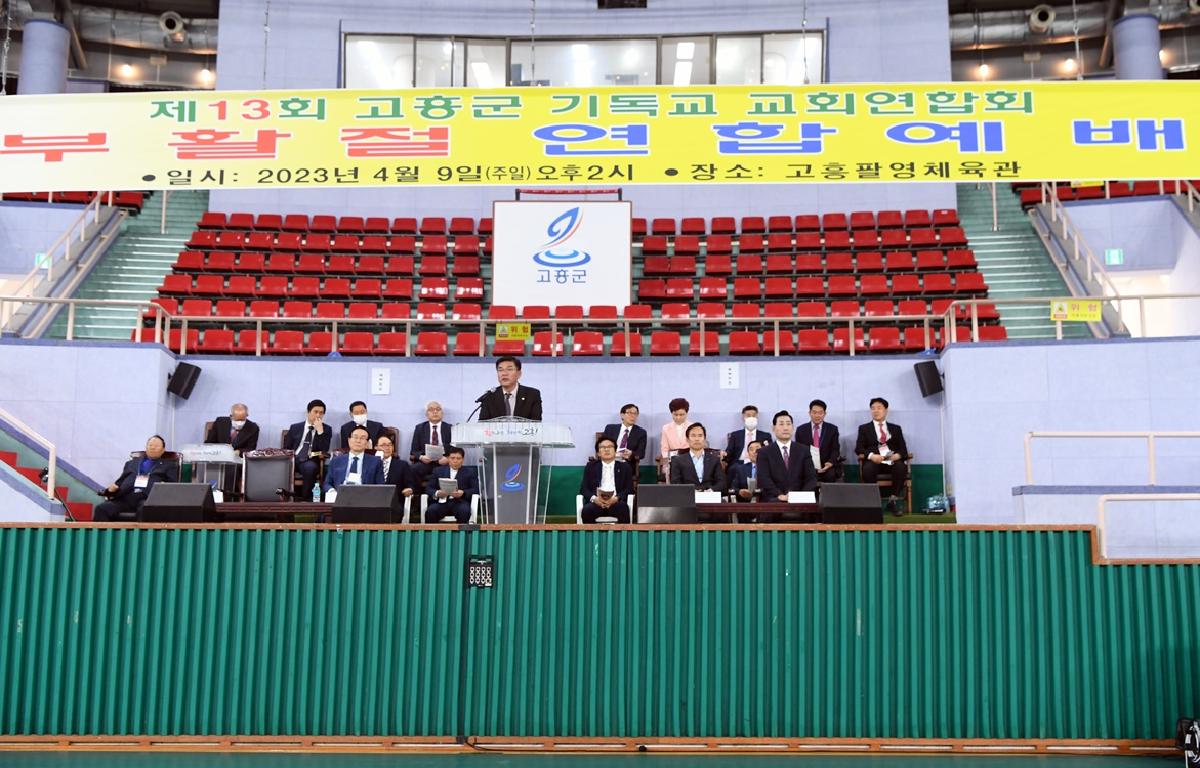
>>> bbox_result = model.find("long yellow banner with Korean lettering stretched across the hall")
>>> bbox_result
[0,80,1200,192]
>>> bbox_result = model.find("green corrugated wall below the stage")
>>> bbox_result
[0,528,1200,739]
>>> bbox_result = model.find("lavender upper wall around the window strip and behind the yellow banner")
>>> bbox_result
[210,0,955,217]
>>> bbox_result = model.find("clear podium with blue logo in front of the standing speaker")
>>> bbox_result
[450,418,575,526]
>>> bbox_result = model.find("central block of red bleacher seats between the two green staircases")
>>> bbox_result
[145,210,1006,356]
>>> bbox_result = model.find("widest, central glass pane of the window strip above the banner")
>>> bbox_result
[511,40,658,88]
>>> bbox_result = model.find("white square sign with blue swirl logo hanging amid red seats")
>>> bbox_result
[492,200,632,307]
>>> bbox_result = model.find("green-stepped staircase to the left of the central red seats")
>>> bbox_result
[46,190,209,341]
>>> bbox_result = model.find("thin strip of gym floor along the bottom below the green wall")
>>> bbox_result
[0,751,1182,768]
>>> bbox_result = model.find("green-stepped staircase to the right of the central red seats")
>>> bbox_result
[958,184,1092,338]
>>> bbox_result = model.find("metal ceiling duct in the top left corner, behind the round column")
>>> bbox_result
[10,0,217,55]
